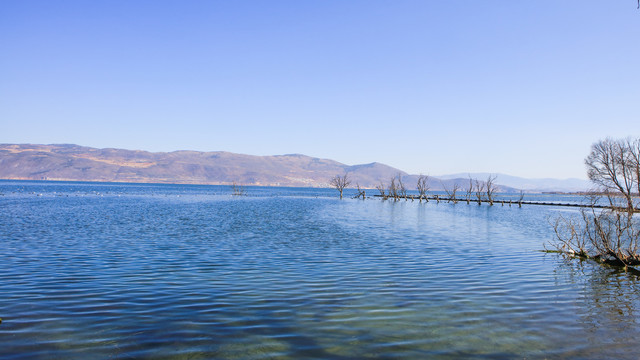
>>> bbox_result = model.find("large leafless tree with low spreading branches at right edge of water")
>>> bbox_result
[552,139,640,267]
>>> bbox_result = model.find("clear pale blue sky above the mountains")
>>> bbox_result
[0,0,640,178]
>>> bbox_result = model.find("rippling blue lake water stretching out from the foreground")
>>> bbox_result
[0,181,640,359]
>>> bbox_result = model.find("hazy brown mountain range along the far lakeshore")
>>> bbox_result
[0,144,584,191]
